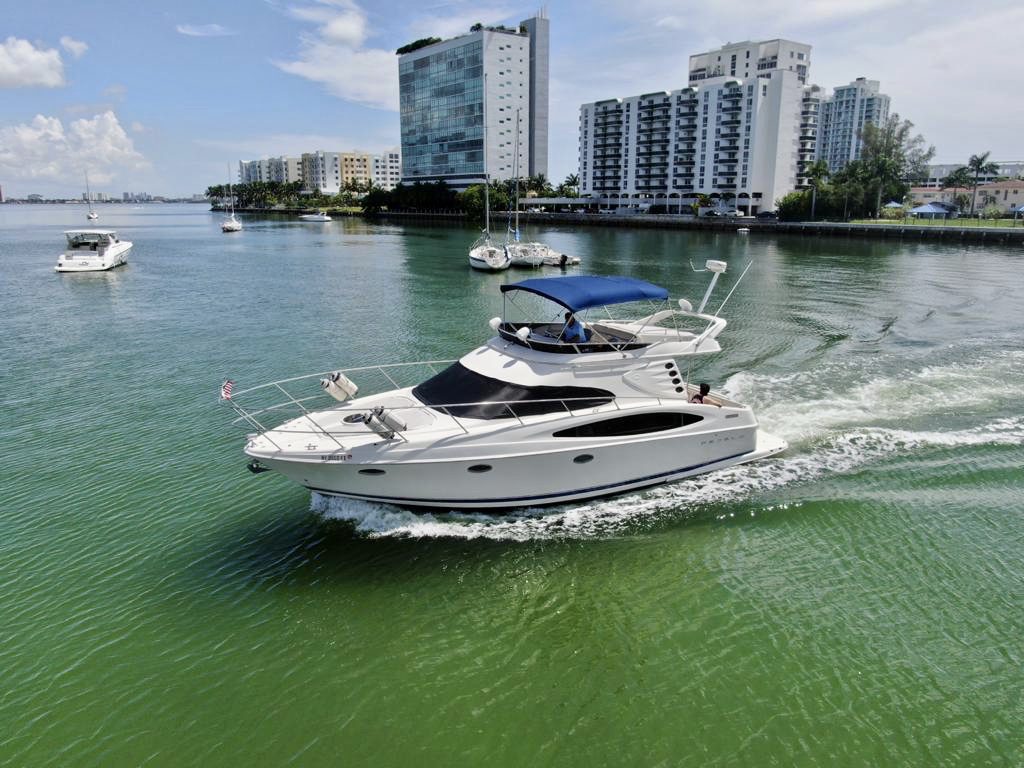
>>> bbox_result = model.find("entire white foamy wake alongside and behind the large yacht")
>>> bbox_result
[311,352,1024,541]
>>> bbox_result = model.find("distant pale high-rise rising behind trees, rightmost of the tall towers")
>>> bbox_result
[817,78,889,171]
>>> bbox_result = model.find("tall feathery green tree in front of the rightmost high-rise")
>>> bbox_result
[860,113,935,216]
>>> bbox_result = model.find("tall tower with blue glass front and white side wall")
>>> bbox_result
[398,13,550,188]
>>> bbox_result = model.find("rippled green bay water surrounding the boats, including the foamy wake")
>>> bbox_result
[0,206,1024,766]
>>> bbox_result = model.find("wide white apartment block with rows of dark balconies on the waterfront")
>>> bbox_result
[580,40,817,213]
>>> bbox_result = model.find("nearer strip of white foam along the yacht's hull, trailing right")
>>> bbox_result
[311,418,1024,541]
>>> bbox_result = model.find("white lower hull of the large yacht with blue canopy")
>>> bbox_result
[251,434,786,510]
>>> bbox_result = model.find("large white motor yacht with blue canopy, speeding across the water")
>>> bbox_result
[221,261,786,509]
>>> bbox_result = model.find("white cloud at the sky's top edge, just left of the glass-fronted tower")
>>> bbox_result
[273,0,398,110]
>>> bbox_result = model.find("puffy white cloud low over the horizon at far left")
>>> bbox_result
[0,112,148,184]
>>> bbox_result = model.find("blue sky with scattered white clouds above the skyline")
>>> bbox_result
[0,0,1024,197]
